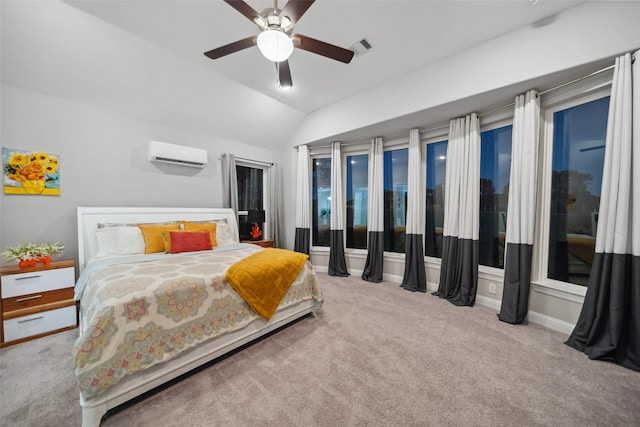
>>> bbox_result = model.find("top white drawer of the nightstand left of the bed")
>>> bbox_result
[2,267,75,298]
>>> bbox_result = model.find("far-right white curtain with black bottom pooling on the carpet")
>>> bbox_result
[566,51,640,371]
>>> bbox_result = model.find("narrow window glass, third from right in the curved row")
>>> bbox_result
[424,141,448,258]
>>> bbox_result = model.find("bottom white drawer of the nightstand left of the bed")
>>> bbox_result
[4,306,76,341]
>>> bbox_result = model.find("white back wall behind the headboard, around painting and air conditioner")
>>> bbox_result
[0,85,280,270]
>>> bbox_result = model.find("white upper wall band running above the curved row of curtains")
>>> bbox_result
[290,2,640,146]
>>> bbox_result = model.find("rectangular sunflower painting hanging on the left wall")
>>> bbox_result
[2,148,60,196]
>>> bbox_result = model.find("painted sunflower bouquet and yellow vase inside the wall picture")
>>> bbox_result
[4,152,58,194]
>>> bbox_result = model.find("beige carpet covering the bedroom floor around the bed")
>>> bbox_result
[0,274,640,427]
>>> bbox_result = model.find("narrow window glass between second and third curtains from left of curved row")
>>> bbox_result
[346,154,369,249]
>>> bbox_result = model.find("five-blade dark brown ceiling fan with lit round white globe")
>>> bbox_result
[204,0,354,89]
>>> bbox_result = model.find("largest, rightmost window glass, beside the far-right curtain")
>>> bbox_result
[547,97,609,286]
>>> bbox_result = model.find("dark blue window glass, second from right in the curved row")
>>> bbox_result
[479,126,512,268]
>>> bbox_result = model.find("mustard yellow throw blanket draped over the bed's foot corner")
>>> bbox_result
[225,248,309,320]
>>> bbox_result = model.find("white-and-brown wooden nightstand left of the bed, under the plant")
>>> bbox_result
[0,260,78,347]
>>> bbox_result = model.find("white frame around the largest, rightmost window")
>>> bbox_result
[531,71,613,303]
